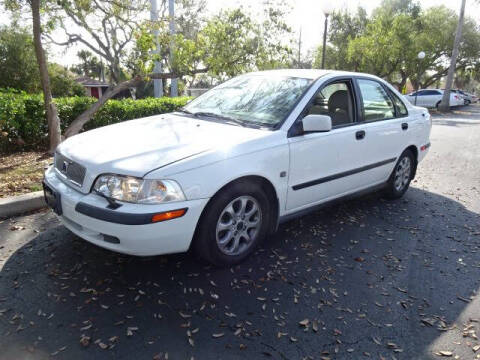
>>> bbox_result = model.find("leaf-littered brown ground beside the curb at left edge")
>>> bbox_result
[0,151,53,198]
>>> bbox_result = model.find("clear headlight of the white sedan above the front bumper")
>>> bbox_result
[93,174,185,204]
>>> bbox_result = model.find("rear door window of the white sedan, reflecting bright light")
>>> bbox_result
[358,79,395,121]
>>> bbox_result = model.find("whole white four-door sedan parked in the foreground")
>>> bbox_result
[44,70,431,266]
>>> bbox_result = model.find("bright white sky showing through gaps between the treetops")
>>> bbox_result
[0,0,480,66]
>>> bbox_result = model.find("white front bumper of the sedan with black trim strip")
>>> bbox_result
[45,167,209,256]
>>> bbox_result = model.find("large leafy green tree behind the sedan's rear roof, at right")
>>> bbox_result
[334,0,480,93]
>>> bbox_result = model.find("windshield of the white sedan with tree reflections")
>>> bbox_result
[183,74,313,127]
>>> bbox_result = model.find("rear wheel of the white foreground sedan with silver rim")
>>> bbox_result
[386,149,416,199]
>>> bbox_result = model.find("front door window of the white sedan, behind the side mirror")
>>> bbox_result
[305,81,354,127]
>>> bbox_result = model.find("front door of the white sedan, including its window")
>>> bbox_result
[286,78,370,211]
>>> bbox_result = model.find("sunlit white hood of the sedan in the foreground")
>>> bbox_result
[57,113,269,177]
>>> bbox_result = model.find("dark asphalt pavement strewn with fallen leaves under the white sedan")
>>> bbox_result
[0,106,480,360]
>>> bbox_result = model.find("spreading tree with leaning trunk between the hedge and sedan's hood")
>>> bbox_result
[4,0,291,137]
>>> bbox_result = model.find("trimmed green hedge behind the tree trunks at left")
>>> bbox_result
[0,89,189,153]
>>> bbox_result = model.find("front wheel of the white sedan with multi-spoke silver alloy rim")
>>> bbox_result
[193,181,270,267]
